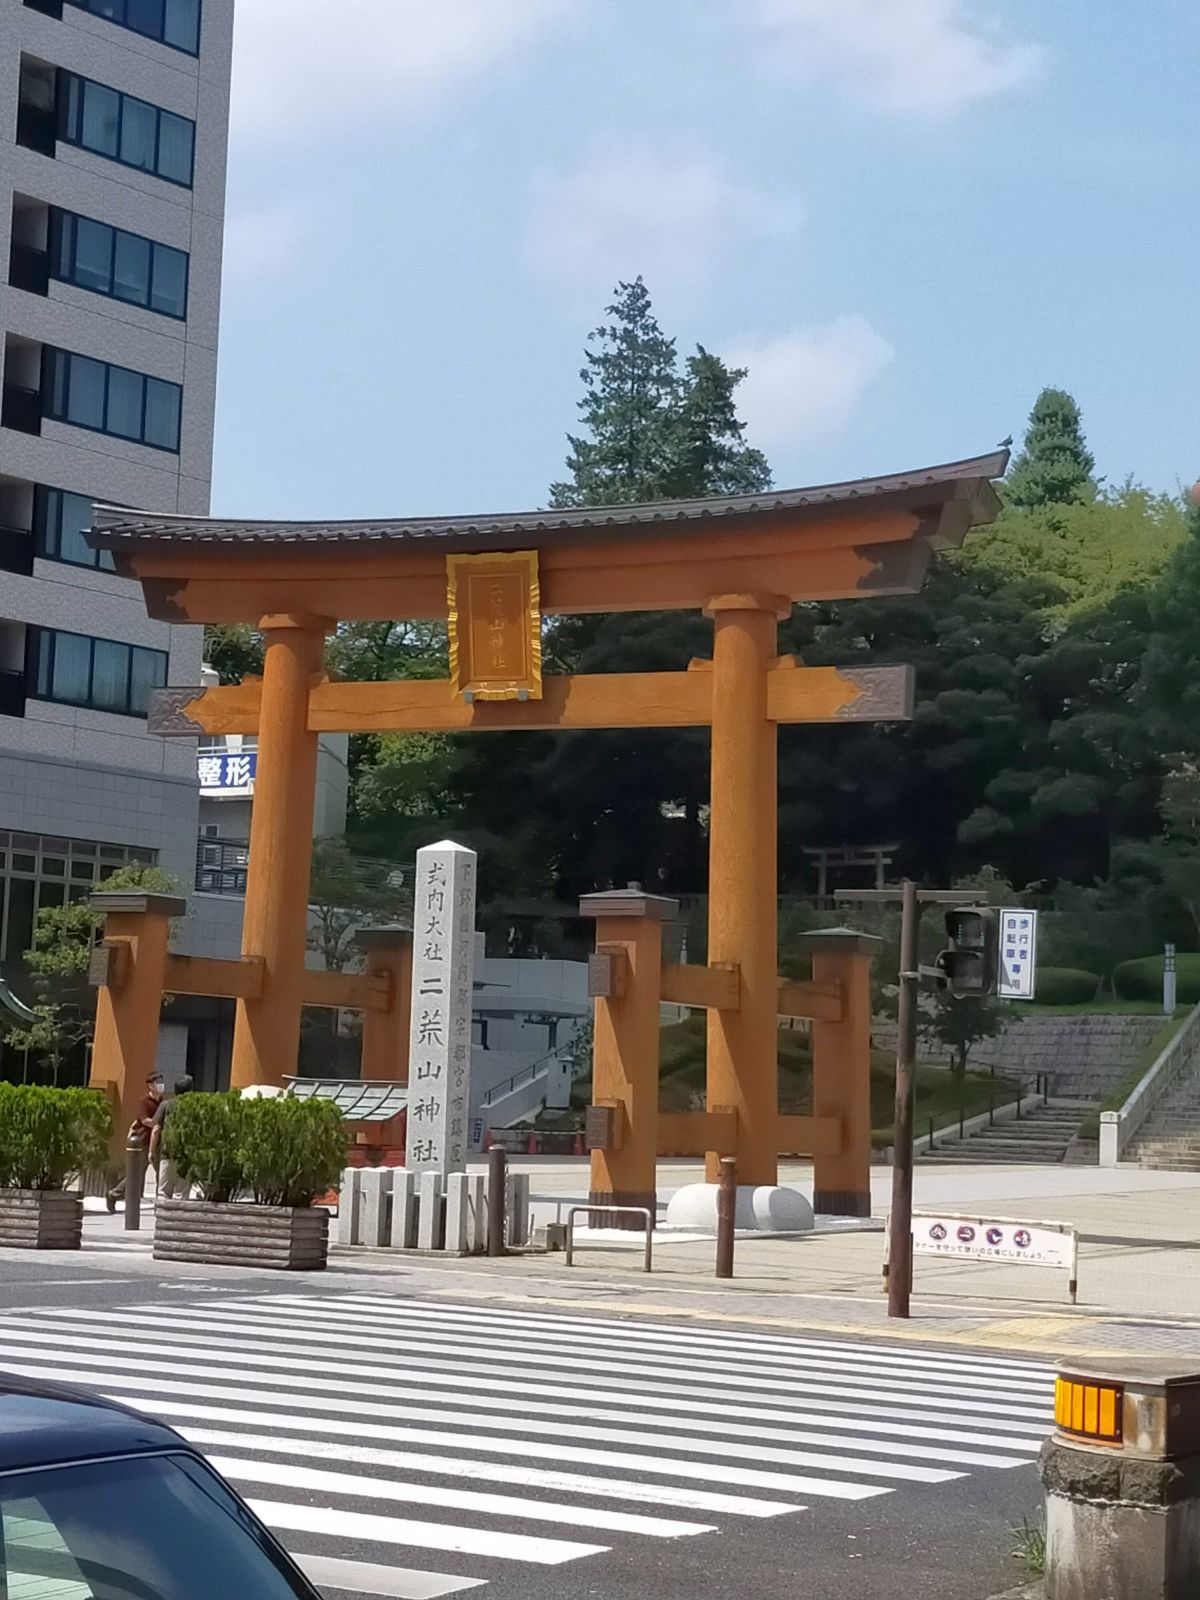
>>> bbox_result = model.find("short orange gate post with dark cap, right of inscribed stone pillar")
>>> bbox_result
[579,888,678,1227]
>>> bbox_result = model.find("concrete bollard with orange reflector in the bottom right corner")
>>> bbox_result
[1040,1360,1200,1600]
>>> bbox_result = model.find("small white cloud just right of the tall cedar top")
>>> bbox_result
[723,315,896,450]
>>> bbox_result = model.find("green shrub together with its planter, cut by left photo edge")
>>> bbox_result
[0,1083,112,1250]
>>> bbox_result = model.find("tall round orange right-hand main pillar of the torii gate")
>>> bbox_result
[704,594,792,1187]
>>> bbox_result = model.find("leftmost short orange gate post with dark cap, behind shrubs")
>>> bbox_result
[88,890,187,1163]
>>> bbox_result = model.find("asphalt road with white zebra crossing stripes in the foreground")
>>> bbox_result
[0,1253,1050,1600]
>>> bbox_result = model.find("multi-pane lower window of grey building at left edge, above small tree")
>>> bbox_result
[0,830,158,963]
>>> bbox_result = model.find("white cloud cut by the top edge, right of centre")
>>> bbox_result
[754,0,1043,117]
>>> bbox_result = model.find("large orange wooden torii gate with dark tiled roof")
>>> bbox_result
[91,453,1006,1214]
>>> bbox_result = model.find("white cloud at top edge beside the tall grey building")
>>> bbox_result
[232,0,578,136]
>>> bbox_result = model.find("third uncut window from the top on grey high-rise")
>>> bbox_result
[42,346,182,454]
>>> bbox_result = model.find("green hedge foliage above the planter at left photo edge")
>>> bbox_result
[0,1083,112,1189]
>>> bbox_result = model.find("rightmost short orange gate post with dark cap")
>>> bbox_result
[800,928,883,1216]
